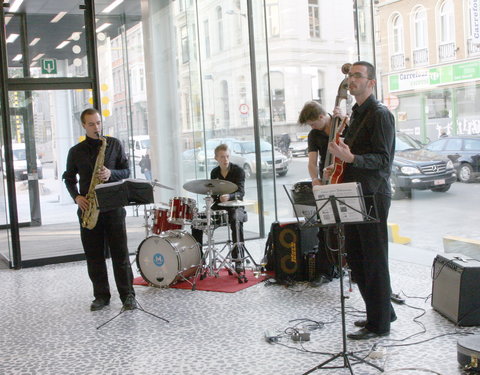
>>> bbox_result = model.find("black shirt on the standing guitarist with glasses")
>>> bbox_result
[343,95,395,195]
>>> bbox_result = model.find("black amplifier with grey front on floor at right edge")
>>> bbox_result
[432,253,480,326]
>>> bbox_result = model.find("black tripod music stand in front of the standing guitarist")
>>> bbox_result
[303,184,383,375]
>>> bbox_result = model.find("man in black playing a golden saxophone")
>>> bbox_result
[62,108,136,311]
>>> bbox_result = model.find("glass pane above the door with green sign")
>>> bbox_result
[6,0,88,78]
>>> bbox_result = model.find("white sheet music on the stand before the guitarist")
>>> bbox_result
[312,182,365,224]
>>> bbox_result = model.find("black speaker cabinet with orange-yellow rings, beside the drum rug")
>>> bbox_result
[271,222,318,281]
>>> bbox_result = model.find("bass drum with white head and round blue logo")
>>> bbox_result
[136,230,202,287]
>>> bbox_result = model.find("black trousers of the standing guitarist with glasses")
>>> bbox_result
[345,194,396,333]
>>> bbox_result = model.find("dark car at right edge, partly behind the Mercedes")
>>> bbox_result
[425,135,480,182]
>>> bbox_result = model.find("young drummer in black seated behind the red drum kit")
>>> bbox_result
[192,144,247,272]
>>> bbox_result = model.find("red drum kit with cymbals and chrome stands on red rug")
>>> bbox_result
[136,180,259,290]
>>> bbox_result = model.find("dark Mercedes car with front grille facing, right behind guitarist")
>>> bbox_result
[390,132,457,199]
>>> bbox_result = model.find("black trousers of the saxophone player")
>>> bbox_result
[78,208,135,302]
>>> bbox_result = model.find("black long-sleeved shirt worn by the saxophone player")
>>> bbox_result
[62,137,130,200]
